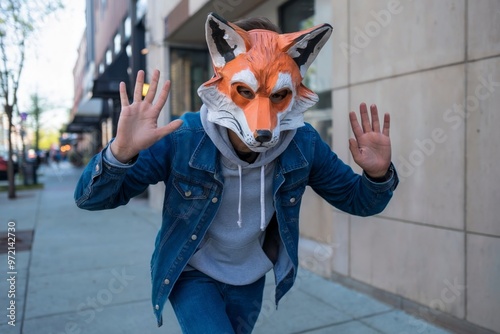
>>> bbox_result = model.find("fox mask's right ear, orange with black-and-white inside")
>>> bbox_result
[280,23,333,77]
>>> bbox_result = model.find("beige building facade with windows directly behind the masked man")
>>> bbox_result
[73,0,500,333]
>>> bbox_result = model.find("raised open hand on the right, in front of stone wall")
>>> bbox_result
[349,103,391,178]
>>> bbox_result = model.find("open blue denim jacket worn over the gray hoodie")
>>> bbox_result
[75,113,398,326]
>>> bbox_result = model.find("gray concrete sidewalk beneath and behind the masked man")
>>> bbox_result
[0,163,448,334]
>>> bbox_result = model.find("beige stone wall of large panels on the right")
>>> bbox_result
[301,0,500,331]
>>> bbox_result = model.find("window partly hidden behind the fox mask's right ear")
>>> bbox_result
[278,0,332,144]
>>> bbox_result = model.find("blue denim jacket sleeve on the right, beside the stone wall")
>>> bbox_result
[309,128,399,216]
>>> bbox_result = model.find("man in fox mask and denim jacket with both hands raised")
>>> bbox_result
[75,14,398,333]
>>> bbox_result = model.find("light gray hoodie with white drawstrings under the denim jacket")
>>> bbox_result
[188,106,296,285]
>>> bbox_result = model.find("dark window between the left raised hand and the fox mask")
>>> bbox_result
[170,48,210,119]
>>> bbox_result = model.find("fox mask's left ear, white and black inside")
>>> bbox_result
[205,13,247,67]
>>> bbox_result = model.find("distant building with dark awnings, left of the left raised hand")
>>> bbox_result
[67,0,147,162]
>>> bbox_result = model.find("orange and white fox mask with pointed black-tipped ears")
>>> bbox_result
[198,13,332,152]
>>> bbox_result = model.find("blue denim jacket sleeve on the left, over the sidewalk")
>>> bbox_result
[74,136,173,210]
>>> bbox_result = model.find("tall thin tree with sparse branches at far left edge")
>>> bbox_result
[0,0,62,199]
